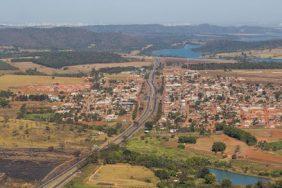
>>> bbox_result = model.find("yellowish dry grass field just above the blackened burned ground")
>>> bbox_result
[0,117,104,149]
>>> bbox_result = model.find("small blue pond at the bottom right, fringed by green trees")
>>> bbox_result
[209,169,269,185]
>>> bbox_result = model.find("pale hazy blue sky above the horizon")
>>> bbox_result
[0,0,282,25]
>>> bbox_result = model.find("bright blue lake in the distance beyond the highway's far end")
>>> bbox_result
[153,44,202,59]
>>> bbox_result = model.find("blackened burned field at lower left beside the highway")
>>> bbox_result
[0,149,70,183]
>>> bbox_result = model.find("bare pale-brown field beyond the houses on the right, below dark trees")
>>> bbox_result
[200,69,282,85]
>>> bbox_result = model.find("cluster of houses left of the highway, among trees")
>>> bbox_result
[56,75,143,122]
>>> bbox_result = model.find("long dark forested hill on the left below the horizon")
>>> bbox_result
[0,27,144,51]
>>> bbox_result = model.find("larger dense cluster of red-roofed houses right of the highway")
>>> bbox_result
[160,67,282,130]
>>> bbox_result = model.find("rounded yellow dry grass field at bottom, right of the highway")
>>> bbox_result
[88,164,158,188]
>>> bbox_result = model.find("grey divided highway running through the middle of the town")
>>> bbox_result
[39,59,159,188]
